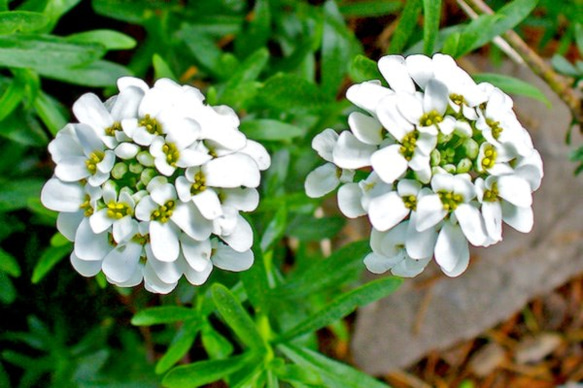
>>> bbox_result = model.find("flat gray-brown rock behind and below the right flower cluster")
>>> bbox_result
[352,59,583,375]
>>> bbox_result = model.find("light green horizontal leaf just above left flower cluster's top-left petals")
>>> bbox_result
[39,60,132,87]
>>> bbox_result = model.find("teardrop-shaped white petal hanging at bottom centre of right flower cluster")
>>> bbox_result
[435,222,470,277]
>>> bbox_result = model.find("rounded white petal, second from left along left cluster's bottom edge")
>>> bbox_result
[102,242,142,283]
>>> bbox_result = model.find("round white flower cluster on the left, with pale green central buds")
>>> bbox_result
[41,77,270,293]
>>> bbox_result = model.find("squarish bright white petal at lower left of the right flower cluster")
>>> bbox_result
[368,191,409,232]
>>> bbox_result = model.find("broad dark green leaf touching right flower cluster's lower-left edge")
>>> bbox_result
[270,240,370,298]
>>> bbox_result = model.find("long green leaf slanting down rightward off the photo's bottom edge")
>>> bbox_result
[278,345,388,388]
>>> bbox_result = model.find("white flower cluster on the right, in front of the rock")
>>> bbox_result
[305,54,543,277]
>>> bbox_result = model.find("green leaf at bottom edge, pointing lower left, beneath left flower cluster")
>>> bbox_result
[162,353,253,388]
